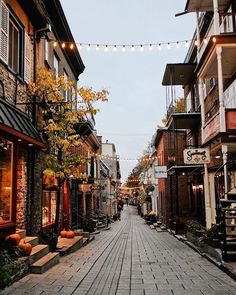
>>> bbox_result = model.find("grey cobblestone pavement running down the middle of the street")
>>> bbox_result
[1,207,236,295]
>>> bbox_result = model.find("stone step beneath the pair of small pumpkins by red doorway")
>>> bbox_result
[57,236,83,256]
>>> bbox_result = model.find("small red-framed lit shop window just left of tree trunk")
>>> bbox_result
[42,191,57,226]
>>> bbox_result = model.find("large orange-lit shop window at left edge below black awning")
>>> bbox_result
[0,138,13,225]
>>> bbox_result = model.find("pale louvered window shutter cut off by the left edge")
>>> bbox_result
[0,1,9,64]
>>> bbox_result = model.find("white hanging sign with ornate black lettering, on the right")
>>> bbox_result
[184,148,210,164]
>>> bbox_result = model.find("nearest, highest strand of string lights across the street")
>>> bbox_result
[47,37,195,52]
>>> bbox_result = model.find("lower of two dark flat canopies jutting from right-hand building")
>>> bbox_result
[167,112,201,130]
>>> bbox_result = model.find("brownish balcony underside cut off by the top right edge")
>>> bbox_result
[185,0,231,12]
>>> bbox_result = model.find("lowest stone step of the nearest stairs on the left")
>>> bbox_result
[30,252,60,274]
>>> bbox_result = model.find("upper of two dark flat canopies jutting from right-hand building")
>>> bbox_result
[162,63,196,86]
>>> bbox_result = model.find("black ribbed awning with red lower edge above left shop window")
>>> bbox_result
[0,98,45,147]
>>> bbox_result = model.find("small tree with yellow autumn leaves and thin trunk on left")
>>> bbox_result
[28,69,108,232]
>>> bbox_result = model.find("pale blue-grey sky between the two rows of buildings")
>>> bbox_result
[61,0,196,181]
